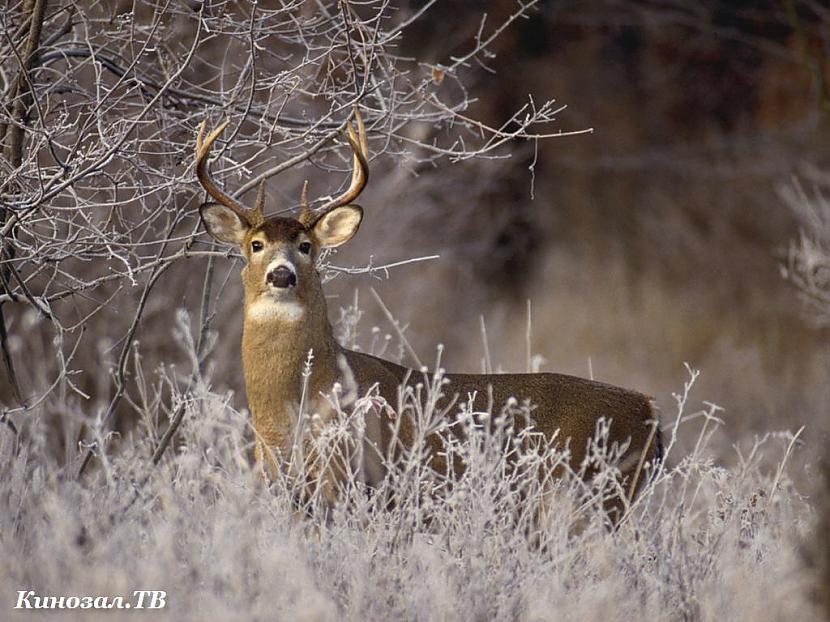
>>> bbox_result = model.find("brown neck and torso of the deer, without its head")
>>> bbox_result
[242,304,659,498]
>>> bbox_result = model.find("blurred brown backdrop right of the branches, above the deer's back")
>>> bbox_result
[331,1,830,452]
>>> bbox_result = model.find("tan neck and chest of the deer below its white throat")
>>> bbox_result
[242,296,342,452]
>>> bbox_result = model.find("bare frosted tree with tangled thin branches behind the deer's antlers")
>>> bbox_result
[0,0,580,468]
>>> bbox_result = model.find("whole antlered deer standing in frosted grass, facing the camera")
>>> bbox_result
[195,108,662,524]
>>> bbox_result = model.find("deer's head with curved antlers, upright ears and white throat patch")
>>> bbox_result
[196,109,369,321]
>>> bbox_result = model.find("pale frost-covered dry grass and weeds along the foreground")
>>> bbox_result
[0,324,819,620]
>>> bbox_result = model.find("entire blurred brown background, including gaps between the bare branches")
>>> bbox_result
[0,0,830,466]
